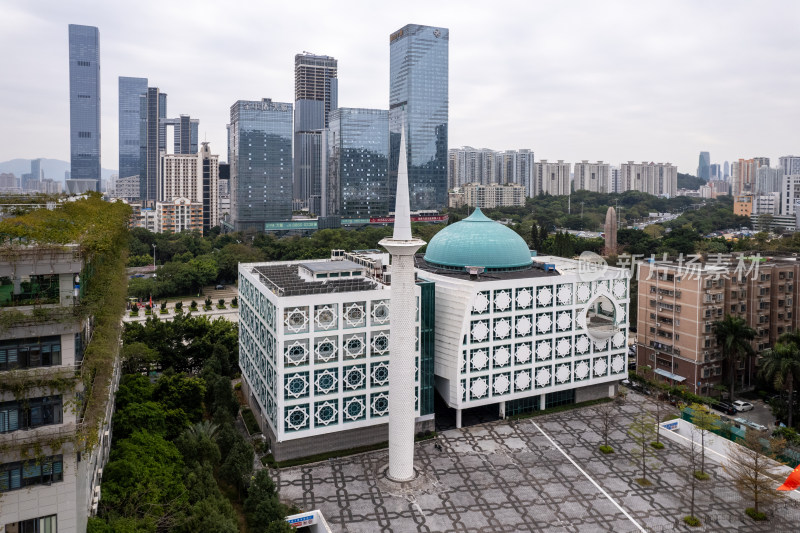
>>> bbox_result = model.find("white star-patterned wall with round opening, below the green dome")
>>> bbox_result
[421,258,629,409]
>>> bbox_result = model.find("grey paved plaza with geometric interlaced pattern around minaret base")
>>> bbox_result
[273,394,800,533]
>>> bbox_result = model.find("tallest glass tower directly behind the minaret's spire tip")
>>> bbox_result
[389,24,450,211]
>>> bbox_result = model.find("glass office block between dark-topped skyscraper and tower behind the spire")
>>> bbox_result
[323,107,389,218]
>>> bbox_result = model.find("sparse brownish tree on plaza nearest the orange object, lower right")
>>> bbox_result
[725,429,786,520]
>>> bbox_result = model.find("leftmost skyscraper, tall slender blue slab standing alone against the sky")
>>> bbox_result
[69,24,101,191]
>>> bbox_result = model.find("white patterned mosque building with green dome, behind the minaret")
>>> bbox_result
[239,209,630,460]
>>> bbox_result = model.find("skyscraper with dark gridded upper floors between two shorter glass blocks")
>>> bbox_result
[293,52,338,213]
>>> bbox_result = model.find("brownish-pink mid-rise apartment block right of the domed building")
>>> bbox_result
[637,259,800,395]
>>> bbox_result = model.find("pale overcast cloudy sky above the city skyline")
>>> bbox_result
[0,0,800,173]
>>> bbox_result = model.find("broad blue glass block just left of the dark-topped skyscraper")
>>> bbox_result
[228,98,293,231]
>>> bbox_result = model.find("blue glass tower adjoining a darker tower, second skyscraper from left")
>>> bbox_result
[119,76,147,178]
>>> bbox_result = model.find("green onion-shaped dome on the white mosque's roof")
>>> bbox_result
[425,209,533,270]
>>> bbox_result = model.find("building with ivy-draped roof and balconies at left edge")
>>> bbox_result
[0,197,128,533]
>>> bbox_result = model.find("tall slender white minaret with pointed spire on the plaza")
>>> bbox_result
[379,124,425,481]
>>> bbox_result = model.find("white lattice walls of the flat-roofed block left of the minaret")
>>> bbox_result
[239,259,421,442]
